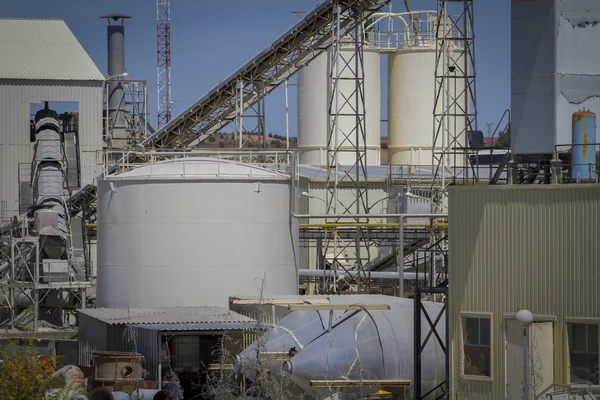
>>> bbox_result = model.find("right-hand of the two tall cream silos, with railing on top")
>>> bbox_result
[388,13,466,165]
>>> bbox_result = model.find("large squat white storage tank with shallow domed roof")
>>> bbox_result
[97,158,297,307]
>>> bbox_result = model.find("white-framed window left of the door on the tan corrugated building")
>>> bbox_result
[463,317,491,377]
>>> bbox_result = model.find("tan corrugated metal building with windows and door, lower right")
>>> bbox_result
[449,184,600,399]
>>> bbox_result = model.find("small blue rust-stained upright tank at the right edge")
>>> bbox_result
[571,110,598,183]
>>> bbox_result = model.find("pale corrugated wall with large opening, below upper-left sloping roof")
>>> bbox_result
[0,80,102,217]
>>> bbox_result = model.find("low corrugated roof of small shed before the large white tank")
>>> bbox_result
[79,307,255,330]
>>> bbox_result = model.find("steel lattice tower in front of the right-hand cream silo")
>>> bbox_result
[432,0,477,195]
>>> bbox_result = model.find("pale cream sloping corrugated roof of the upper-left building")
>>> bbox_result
[0,19,104,81]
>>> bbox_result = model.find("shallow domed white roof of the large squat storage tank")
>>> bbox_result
[105,157,290,180]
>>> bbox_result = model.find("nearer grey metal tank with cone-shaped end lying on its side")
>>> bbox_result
[283,298,446,398]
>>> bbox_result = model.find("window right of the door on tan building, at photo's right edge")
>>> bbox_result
[569,323,599,385]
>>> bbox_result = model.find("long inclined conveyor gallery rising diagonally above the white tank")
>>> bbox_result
[68,0,389,216]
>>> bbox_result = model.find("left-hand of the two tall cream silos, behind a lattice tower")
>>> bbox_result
[298,47,381,165]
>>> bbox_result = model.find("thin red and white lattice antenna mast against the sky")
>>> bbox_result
[156,0,172,129]
